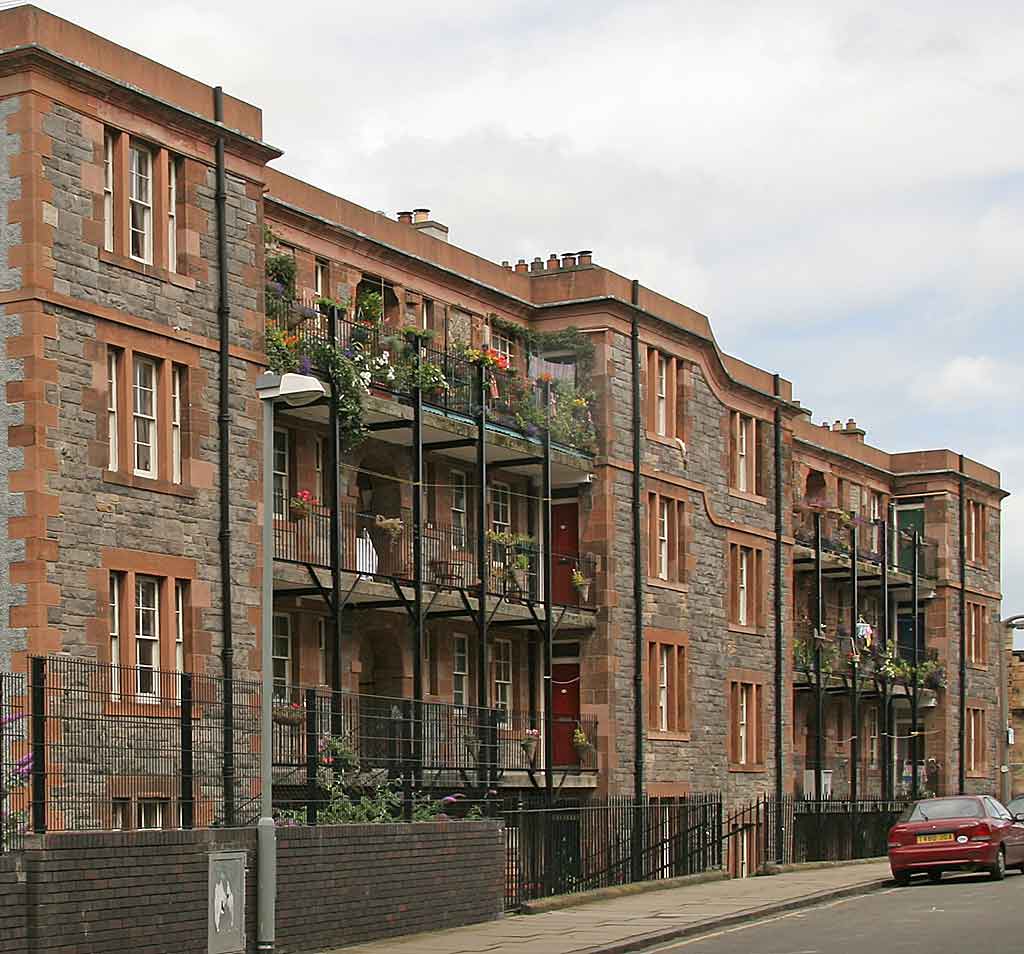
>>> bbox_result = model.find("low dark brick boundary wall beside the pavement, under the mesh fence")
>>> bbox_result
[0,821,505,954]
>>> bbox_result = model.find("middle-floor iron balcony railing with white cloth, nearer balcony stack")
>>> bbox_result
[274,504,597,609]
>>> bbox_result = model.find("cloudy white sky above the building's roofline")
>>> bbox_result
[32,0,1024,615]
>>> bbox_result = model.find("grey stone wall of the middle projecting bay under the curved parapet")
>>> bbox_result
[607,334,792,800]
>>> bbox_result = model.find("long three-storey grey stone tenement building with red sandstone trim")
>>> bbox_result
[0,6,1006,825]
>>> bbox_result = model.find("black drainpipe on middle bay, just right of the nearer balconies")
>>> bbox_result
[631,279,644,879]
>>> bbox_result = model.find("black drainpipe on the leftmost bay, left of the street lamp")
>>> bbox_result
[213,86,234,827]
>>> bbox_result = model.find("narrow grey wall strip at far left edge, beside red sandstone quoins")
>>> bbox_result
[0,96,26,669]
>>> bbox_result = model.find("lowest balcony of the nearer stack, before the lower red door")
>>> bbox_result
[273,689,598,787]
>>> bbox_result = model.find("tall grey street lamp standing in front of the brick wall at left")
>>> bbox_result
[256,373,327,952]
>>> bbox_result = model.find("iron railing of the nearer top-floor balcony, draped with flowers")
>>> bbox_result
[266,295,597,453]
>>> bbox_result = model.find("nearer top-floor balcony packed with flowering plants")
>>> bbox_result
[266,296,597,456]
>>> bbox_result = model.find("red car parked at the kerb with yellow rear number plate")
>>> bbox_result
[889,795,1024,885]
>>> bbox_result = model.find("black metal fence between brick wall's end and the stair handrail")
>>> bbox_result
[502,793,722,909]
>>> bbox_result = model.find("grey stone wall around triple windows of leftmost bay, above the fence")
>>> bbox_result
[43,104,261,677]
